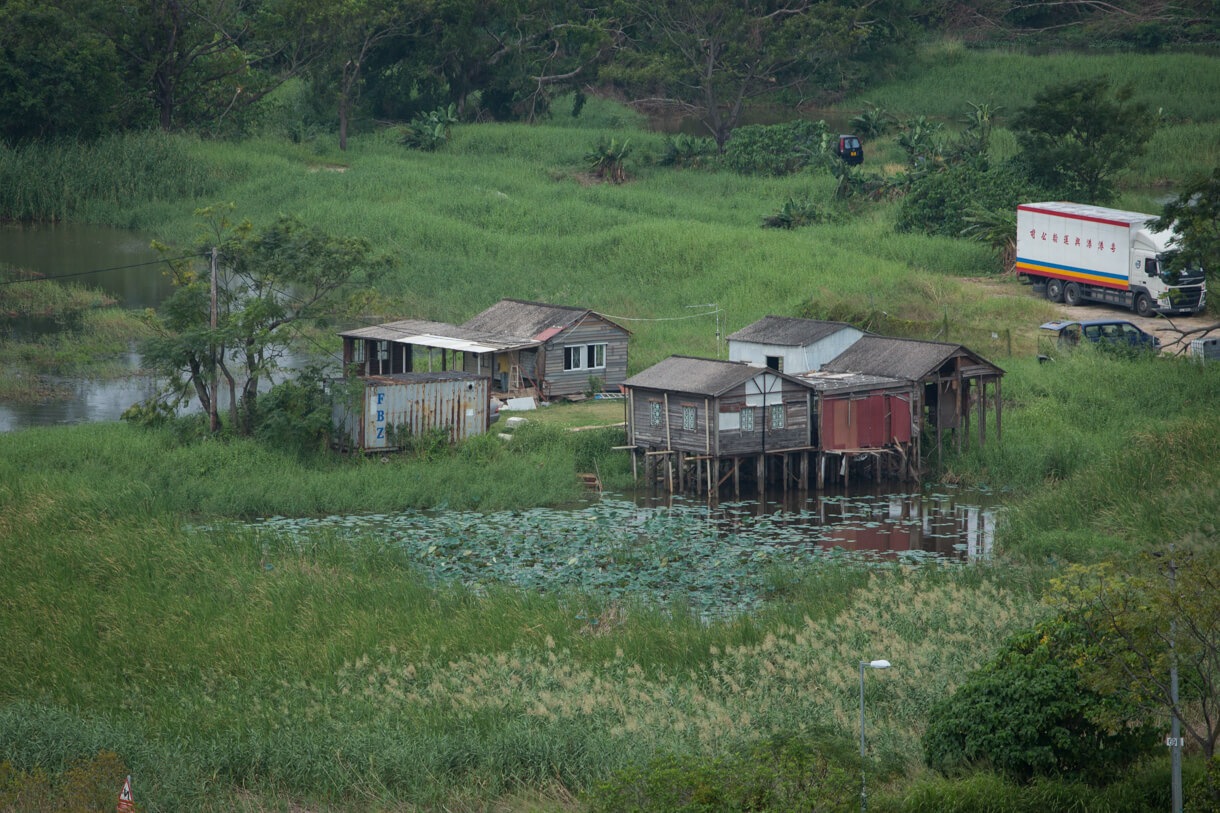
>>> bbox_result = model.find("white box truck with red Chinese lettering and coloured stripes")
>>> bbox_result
[1016,203,1207,316]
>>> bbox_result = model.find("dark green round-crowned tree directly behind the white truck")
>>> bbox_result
[1014,78,1157,204]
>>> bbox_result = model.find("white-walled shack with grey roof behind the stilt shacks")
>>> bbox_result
[728,316,866,375]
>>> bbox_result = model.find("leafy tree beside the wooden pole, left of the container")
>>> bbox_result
[144,206,388,432]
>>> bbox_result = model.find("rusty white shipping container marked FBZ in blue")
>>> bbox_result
[332,371,490,452]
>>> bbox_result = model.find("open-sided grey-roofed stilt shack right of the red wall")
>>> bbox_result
[822,336,1004,460]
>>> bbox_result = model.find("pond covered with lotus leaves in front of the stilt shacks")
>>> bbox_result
[242,483,999,619]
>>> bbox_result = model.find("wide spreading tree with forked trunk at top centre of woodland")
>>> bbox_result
[604,0,906,150]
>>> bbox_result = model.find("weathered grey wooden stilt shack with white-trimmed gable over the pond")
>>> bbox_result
[623,355,813,492]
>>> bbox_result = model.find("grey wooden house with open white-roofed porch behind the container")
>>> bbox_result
[340,299,631,400]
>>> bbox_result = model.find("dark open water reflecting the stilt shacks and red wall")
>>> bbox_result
[633,483,998,558]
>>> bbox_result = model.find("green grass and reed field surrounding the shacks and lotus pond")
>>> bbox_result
[0,50,1220,811]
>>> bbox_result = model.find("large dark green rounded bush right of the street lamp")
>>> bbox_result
[924,619,1154,782]
